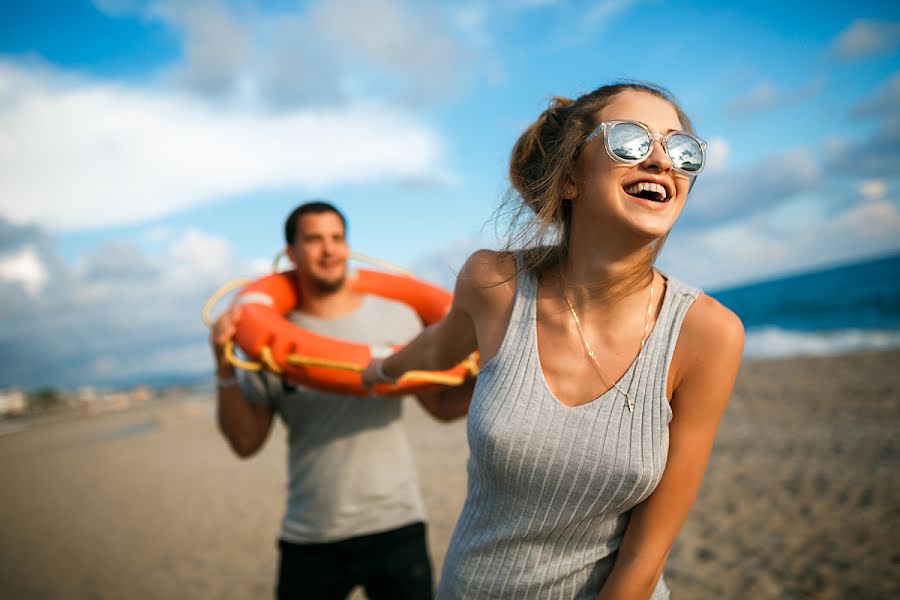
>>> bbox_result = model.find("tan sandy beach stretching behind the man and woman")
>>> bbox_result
[0,350,900,600]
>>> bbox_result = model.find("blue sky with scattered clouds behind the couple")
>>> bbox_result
[0,0,900,386]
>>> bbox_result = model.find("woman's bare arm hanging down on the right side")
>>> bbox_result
[598,295,744,600]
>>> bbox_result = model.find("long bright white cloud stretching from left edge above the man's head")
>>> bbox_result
[0,62,444,229]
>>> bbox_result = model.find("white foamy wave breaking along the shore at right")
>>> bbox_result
[744,327,900,358]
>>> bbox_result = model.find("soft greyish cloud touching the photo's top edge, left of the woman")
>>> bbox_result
[115,0,490,108]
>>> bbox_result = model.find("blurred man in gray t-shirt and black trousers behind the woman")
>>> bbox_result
[210,202,472,600]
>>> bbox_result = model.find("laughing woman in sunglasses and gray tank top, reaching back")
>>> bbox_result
[363,83,744,600]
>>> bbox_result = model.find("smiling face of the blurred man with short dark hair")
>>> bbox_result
[286,212,350,292]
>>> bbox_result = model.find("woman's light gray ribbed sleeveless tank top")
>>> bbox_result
[437,256,700,600]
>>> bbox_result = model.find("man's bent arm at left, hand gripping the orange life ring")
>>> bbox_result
[209,308,272,458]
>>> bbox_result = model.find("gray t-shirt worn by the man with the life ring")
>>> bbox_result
[242,295,425,544]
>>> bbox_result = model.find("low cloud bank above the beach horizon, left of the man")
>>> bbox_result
[0,226,252,387]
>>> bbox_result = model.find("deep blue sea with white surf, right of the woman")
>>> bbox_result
[709,254,900,358]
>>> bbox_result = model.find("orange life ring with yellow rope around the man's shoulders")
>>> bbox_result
[234,269,478,396]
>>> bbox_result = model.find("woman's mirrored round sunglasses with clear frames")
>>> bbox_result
[584,121,706,177]
